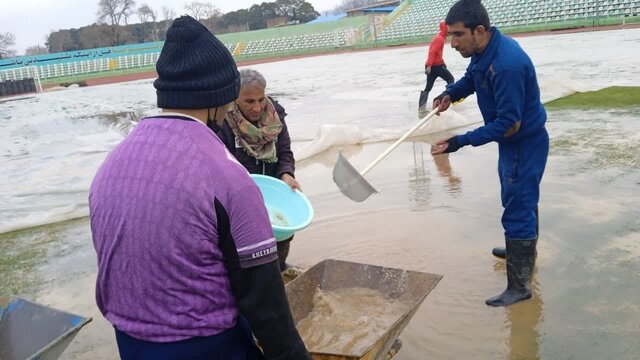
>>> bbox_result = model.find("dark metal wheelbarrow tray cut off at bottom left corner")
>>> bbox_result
[0,296,91,360]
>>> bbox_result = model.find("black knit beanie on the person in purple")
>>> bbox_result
[153,16,240,109]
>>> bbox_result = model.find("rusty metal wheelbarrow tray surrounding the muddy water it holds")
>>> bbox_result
[286,260,442,360]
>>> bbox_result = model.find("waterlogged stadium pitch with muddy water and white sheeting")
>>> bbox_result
[0,30,640,360]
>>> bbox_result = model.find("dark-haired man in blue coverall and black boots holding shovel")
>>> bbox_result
[432,0,549,306]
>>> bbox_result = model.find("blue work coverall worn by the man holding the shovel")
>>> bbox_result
[447,27,549,240]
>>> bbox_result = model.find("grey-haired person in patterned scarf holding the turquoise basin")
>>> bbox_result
[211,69,300,271]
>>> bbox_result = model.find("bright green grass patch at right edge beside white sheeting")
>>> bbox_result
[545,86,640,109]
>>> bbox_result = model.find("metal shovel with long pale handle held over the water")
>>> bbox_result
[333,108,438,202]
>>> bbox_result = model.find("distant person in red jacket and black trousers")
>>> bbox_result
[418,21,454,109]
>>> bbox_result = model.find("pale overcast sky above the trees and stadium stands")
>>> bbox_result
[0,0,342,54]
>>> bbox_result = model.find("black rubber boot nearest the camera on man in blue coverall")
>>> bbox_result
[485,240,537,306]
